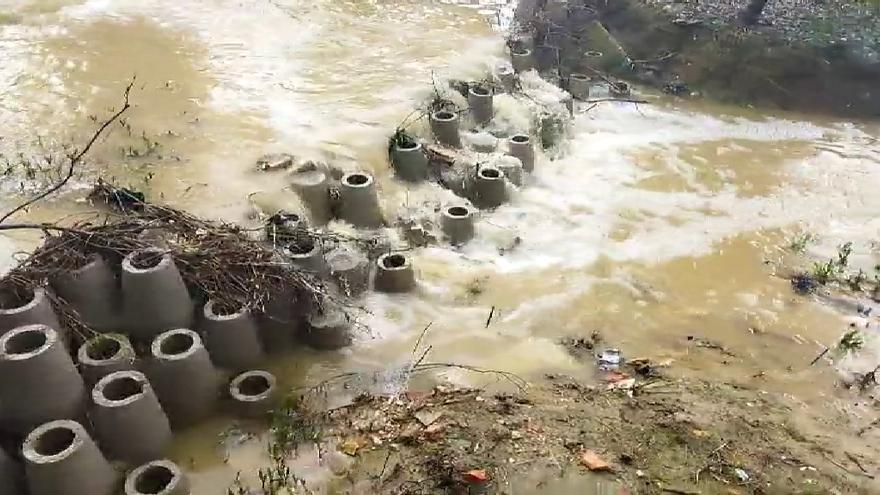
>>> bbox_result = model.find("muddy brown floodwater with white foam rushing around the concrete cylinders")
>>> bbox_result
[0,0,880,494]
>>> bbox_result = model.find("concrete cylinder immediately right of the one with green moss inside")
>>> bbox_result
[147,328,218,427]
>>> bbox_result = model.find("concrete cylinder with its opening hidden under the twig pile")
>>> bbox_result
[52,255,120,332]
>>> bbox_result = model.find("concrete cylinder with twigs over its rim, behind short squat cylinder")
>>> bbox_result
[202,300,264,371]
